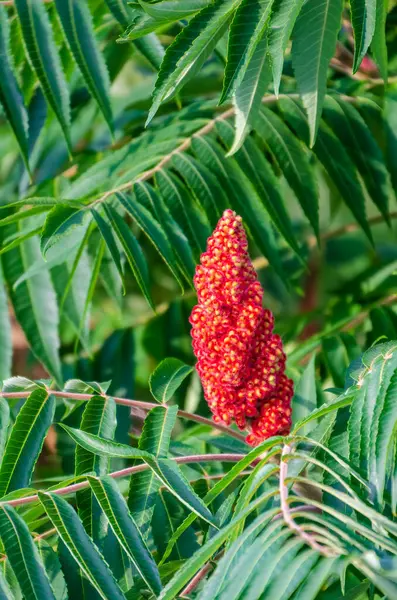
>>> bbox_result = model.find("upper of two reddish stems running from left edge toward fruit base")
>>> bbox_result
[0,390,245,442]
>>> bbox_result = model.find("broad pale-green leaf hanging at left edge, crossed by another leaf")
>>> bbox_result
[2,230,62,385]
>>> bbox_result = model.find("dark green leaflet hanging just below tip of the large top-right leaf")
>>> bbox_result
[254,107,319,238]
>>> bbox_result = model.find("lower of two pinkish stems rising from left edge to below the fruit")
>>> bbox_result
[0,454,245,506]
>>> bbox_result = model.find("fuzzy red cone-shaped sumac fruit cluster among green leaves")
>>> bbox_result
[190,210,293,445]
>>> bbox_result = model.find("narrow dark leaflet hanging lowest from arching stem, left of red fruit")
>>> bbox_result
[104,204,154,310]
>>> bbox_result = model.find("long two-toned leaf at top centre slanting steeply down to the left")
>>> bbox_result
[147,0,238,123]
